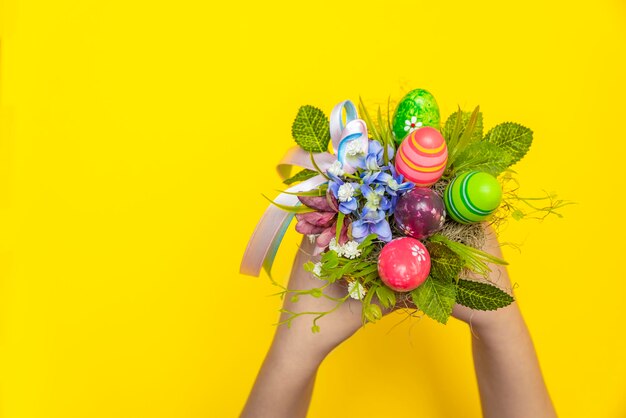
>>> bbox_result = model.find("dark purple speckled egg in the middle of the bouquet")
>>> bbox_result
[393,187,446,239]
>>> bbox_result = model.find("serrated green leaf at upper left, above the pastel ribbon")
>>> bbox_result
[291,105,330,152]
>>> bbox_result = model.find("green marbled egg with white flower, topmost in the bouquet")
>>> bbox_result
[392,89,439,144]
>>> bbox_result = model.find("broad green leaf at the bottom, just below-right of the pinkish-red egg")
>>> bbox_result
[411,276,456,324]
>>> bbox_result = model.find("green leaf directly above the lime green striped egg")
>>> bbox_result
[451,141,511,177]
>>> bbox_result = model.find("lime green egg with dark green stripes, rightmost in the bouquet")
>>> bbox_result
[444,171,502,224]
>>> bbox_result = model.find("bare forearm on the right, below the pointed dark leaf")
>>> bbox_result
[472,304,556,418]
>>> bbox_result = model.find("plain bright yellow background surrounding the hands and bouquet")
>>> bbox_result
[0,0,626,418]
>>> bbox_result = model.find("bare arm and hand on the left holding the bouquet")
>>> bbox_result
[241,238,363,418]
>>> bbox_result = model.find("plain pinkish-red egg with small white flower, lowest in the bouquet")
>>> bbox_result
[378,237,430,292]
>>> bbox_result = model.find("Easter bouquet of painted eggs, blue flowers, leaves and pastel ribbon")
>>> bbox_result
[241,89,568,332]
